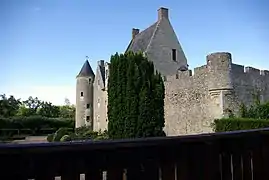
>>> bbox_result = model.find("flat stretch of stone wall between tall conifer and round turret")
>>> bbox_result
[164,66,210,135]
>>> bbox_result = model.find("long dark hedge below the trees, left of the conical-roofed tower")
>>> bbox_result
[0,116,75,134]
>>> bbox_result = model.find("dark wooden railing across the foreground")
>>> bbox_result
[0,129,269,180]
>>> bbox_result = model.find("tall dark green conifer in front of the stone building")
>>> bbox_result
[108,52,164,138]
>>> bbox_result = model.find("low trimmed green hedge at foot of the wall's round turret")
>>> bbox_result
[213,118,269,132]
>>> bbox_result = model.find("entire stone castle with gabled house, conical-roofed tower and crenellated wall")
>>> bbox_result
[76,8,269,135]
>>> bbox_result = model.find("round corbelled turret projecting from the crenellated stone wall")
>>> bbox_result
[206,52,234,118]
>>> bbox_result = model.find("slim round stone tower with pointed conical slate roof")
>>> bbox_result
[76,60,95,128]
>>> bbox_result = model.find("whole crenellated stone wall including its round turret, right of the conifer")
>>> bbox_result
[165,52,269,136]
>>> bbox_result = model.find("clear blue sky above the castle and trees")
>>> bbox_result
[0,0,269,104]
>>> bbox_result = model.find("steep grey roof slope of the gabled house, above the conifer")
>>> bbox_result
[126,22,158,52]
